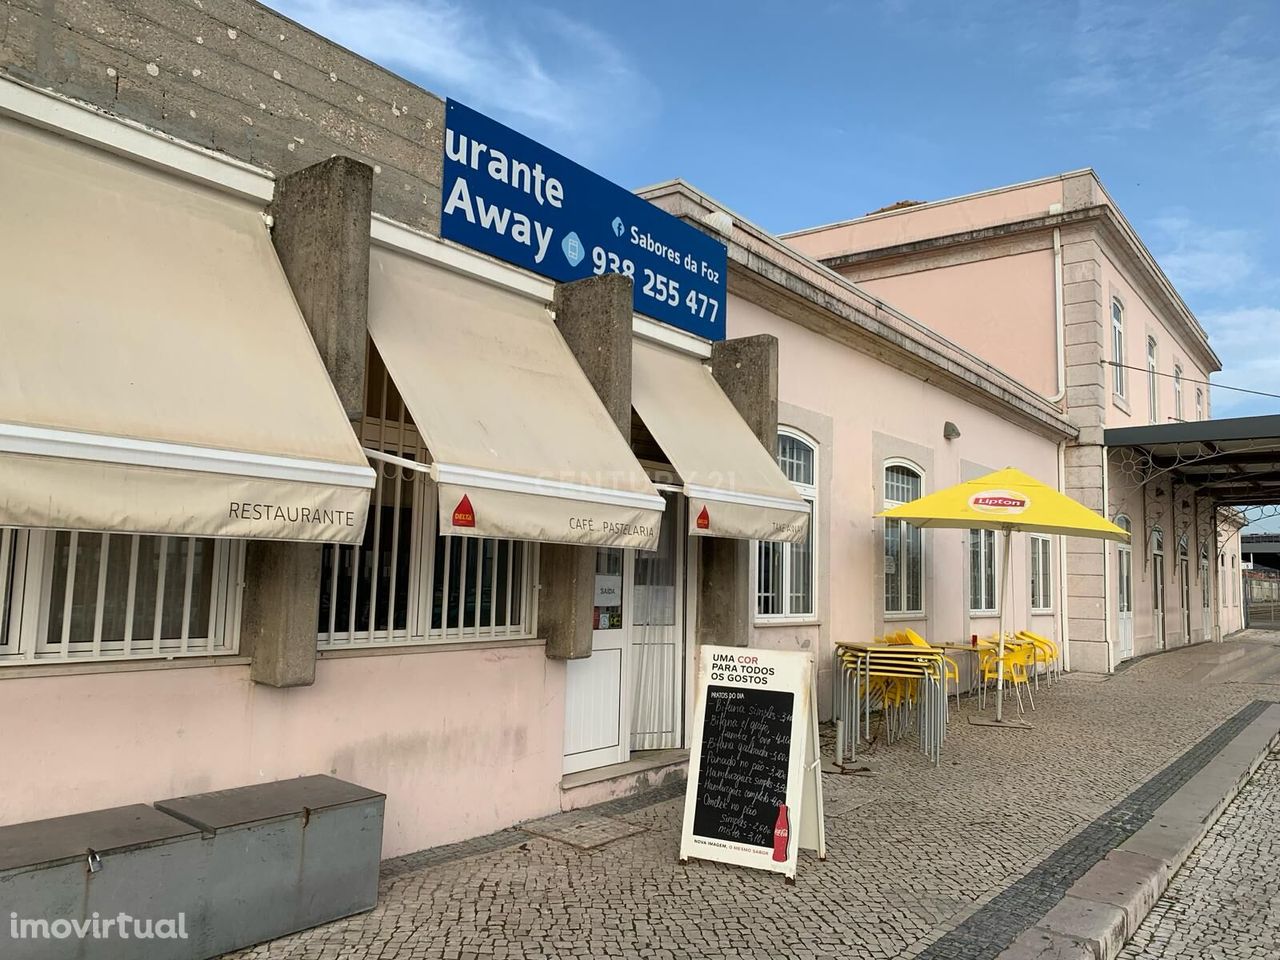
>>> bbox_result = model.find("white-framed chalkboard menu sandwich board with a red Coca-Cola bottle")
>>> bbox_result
[680,645,827,881]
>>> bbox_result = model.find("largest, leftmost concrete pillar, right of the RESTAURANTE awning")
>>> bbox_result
[241,156,372,687]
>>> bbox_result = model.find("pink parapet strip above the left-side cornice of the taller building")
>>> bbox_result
[782,178,1062,260]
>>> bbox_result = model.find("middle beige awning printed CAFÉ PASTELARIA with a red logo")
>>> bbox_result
[369,247,663,550]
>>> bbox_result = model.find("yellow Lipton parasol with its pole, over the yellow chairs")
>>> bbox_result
[878,467,1129,721]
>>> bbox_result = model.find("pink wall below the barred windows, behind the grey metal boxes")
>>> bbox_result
[0,646,564,856]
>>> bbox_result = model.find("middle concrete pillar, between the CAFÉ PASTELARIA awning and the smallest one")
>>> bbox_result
[538,274,632,660]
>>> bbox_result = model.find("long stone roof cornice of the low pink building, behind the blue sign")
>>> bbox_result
[639,180,1079,440]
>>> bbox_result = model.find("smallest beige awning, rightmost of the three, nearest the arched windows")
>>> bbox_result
[631,339,809,541]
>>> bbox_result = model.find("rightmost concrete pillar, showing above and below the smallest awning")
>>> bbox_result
[698,334,778,646]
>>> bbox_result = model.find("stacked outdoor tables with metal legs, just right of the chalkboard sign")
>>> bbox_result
[835,640,946,764]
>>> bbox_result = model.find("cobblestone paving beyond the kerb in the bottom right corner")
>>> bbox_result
[1119,754,1280,960]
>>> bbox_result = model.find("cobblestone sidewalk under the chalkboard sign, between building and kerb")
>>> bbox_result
[232,631,1280,960]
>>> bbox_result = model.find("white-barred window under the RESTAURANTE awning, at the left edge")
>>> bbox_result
[0,529,243,664]
